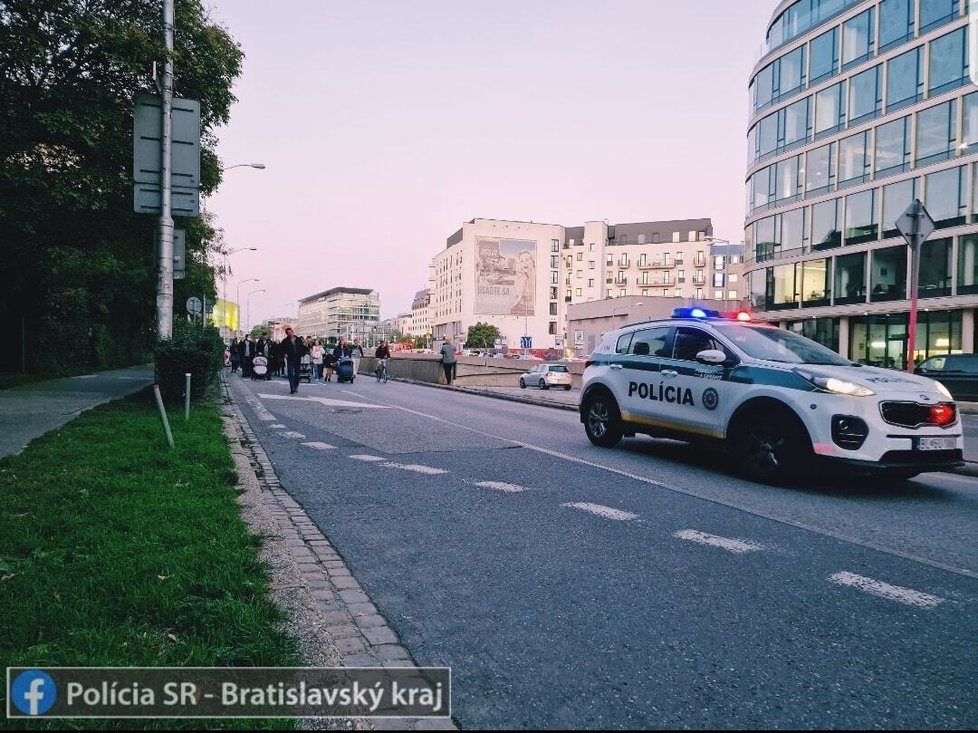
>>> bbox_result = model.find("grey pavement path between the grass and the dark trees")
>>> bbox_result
[0,364,153,456]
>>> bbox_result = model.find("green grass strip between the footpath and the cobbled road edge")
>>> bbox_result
[0,391,301,728]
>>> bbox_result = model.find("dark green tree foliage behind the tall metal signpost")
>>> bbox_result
[0,0,243,373]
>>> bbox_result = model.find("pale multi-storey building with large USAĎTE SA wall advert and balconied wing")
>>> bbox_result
[429,219,742,349]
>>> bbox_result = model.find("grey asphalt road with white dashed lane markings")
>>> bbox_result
[232,378,978,728]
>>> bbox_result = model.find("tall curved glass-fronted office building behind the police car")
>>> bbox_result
[744,0,978,368]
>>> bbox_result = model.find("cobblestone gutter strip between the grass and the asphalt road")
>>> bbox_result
[223,380,456,730]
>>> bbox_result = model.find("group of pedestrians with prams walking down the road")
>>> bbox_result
[228,334,363,394]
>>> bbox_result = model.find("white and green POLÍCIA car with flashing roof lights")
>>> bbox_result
[580,308,964,482]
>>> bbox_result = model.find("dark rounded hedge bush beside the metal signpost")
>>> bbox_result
[156,320,224,403]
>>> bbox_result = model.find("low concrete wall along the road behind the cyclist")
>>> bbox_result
[360,354,584,388]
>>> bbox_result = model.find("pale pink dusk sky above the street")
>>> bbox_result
[204,0,777,323]
